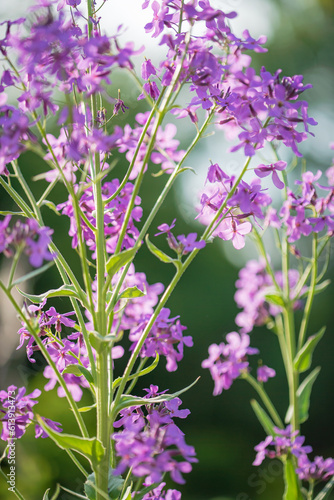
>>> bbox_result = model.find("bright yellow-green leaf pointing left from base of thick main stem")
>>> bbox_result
[36,415,105,467]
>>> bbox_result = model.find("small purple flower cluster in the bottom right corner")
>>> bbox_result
[253,425,334,481]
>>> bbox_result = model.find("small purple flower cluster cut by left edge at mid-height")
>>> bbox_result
[0,215,55,267]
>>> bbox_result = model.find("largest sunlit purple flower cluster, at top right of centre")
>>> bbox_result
[144,1,316,156]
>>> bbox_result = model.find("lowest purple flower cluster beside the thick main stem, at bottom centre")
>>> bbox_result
[113,386,197,484]
